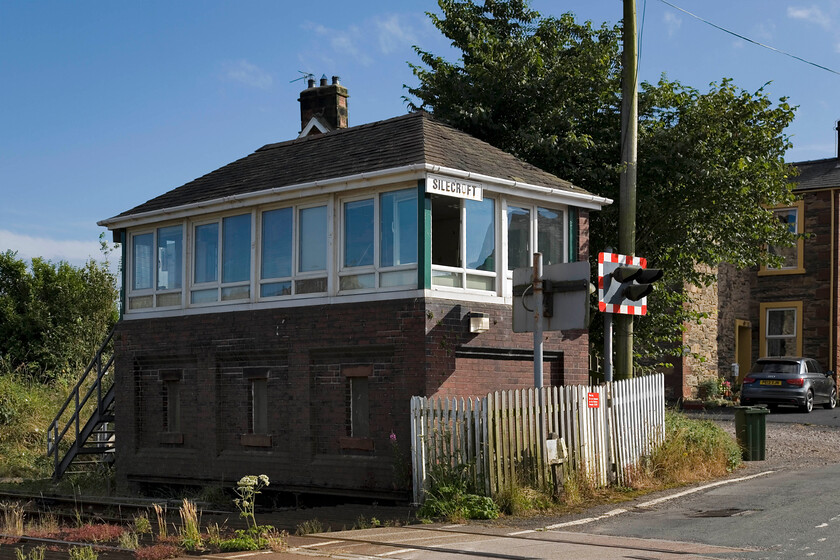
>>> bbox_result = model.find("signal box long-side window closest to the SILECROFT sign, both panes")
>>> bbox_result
[339,189,417,291]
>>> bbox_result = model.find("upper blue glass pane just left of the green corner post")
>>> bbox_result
[379,189,417,267]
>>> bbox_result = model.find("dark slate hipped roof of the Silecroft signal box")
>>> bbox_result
[106,111,590,222]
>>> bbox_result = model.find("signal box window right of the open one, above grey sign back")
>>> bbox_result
[507,204,566,270]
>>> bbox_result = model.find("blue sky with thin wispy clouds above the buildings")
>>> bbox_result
[0,0,840,264]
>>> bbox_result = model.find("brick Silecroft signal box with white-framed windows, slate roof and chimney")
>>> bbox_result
[100,78,610,496]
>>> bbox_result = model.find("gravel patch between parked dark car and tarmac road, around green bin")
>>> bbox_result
[715,420,840,476]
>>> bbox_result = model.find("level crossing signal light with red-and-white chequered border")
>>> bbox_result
[598,253,662,315]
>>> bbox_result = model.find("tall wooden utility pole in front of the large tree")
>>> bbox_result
[616,0,639,379]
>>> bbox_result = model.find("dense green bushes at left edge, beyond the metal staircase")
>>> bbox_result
[0,251,117,381]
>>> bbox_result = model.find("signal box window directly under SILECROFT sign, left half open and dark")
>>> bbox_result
[432,195,496,291]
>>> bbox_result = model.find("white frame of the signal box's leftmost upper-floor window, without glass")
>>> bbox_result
[126,221,189,313]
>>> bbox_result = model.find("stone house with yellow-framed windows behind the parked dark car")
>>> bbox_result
[666,126,840,398]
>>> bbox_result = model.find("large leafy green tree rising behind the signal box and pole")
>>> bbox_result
[407,0,794,372]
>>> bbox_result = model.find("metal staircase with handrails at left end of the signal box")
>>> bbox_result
[47,331,115,480]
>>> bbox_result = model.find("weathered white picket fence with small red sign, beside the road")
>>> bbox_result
[411,374,665,503]
